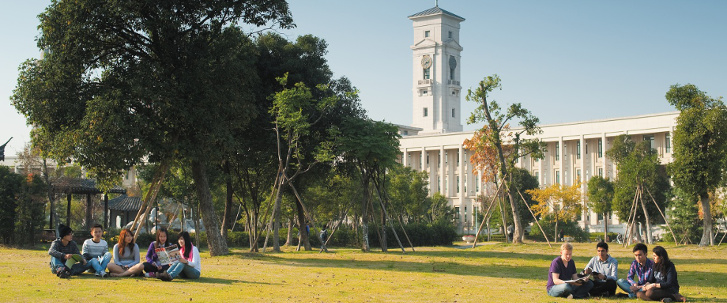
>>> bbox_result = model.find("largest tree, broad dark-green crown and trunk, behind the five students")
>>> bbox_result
[12,0,293,256]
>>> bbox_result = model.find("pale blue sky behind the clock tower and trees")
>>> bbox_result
[0,0,727,155]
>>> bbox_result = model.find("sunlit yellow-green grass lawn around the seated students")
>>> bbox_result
[0,243,727,302]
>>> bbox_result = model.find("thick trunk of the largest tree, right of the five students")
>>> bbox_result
[192,160,229,256]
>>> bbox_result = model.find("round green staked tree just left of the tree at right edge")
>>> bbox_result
[606,134,670,243]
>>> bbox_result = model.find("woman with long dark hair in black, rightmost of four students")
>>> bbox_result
[636,246,686,302]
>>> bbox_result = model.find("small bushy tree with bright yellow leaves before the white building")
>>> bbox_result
[527,180,583,241]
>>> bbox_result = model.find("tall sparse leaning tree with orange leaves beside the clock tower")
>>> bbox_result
[464,75,545,243]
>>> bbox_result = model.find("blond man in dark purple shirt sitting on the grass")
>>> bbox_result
[547,243,593,299]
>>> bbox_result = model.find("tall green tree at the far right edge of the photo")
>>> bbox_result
[666,84,727,246]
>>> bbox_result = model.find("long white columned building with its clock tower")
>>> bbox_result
[399,6,679,236]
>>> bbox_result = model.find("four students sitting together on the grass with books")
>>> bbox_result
[547,242,686,302]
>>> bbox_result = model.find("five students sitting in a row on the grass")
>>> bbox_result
[48,224,202,281]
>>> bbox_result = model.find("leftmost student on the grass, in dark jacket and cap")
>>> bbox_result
[48,224,86,279]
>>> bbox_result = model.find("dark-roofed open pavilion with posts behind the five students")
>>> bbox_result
[49,177,126,229]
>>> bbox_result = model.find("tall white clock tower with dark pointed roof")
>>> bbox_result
[409,5,464,134]
